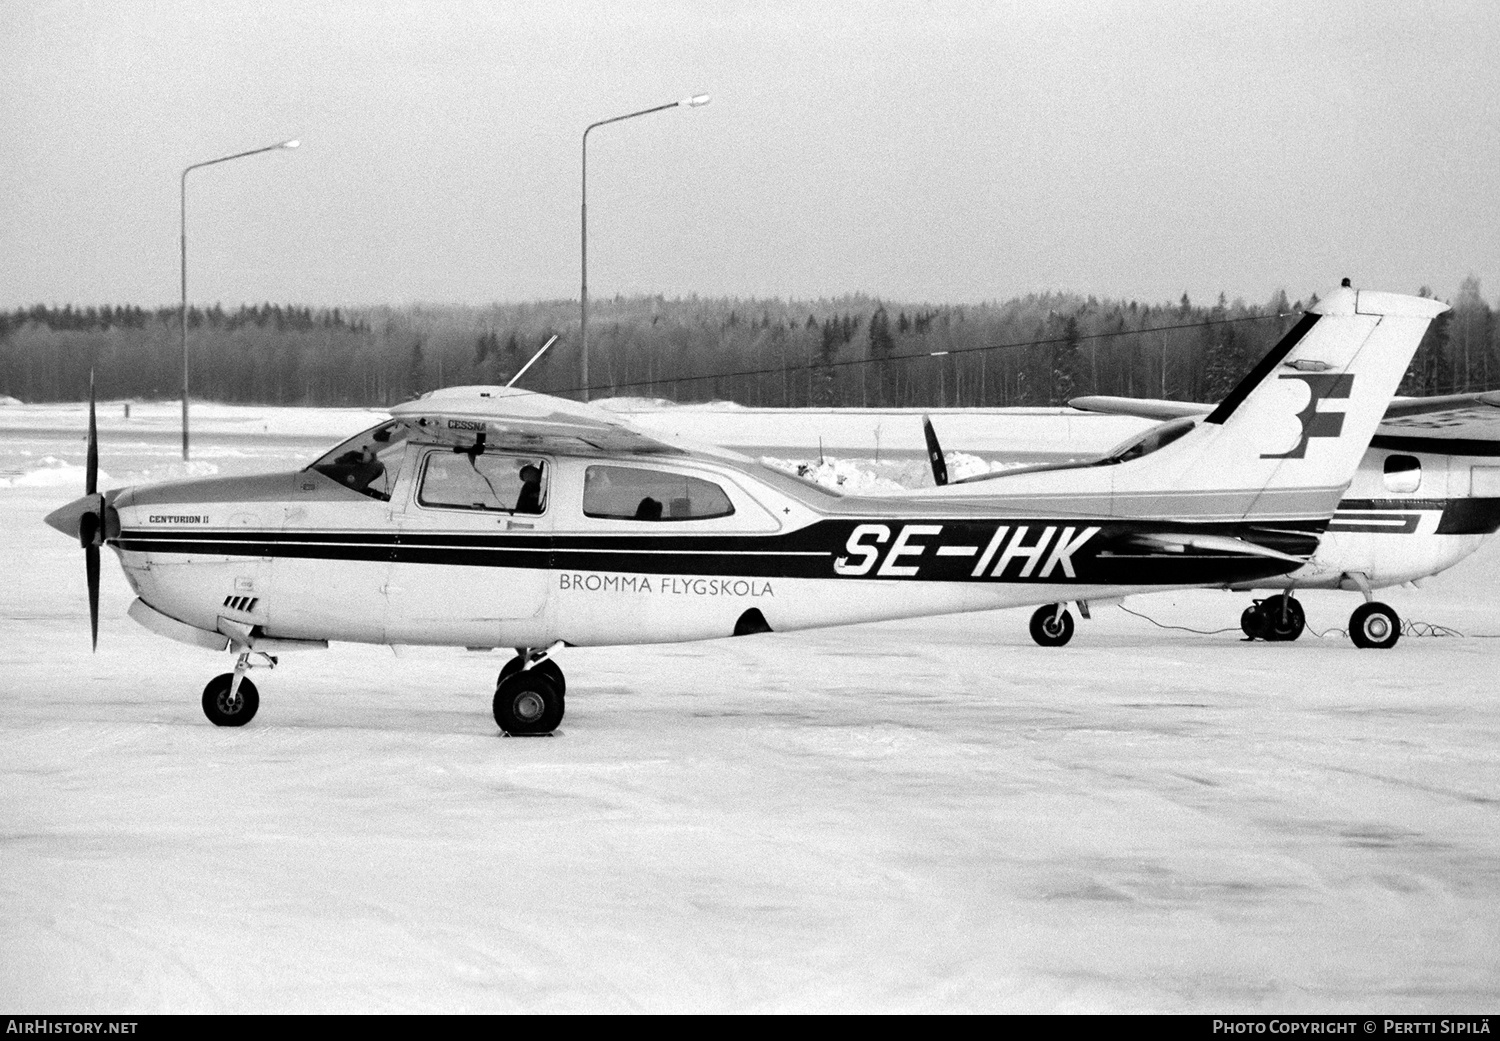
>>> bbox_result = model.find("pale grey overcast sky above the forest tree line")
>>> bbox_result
[0,0,1500,308]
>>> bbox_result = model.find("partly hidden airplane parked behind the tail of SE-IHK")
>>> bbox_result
[1068,392,1500,648]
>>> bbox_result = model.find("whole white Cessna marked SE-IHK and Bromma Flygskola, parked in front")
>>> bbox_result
[47,290,1443,734]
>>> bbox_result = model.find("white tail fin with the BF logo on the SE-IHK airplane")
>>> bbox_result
[1112,287,1448,518]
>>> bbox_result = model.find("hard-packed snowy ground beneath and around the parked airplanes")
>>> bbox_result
[0,399,1500,1014]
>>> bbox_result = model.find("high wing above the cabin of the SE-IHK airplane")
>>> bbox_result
[390,387,696,455]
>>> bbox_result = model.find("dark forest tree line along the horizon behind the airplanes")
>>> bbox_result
[0,276,1500,408]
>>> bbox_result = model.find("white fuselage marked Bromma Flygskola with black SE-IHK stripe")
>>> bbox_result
[111,444,1314,648]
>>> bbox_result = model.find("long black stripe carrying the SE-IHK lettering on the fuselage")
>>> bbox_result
[114,518,1325,585]
